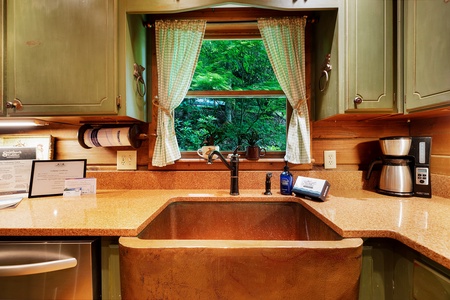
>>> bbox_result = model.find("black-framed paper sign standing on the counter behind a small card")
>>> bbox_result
[28,159,87,198]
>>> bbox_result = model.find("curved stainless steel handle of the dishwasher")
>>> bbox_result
[0,257,77,277]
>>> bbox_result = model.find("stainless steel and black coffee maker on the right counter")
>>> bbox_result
[366,136,431,198]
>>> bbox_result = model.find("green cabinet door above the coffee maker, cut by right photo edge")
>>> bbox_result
[404,0,450,112]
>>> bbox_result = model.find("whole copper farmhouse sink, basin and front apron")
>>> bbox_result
[119,199,362,299]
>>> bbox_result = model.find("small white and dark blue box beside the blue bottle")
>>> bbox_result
[292,176,330,201]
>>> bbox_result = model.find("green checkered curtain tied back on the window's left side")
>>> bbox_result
[152,20,206,167]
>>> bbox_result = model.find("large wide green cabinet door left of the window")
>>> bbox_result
[4,0,117,116]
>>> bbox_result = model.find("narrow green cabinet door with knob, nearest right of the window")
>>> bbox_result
[340,0,397,112]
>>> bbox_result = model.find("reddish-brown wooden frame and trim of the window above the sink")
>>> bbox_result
[146,8,312,170]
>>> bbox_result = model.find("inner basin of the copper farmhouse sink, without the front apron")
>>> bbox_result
[139,201,342,241]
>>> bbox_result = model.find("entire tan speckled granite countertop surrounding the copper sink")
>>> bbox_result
[0,189,450,268]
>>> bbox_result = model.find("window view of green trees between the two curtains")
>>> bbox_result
[175,39,287,151]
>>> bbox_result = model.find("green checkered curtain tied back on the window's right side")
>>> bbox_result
[258,17,311,164]
